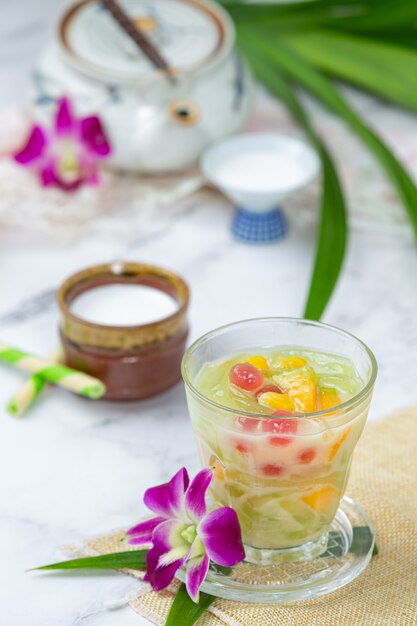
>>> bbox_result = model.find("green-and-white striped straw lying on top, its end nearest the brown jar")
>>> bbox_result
[0,343,106,400]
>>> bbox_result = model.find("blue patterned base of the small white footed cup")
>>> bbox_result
[232,208,287,244]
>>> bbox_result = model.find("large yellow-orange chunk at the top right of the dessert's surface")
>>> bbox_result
[273,365,317,413]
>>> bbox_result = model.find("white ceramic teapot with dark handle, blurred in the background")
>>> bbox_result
[32,0,252,173]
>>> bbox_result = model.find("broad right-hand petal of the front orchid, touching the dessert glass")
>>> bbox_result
[197,506,245,567]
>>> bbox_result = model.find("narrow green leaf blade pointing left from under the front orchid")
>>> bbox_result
[34,549,148,570]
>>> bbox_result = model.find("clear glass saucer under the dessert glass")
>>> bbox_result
[177,497,375,604]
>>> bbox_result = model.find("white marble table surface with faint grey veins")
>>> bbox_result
[0,1,417,626]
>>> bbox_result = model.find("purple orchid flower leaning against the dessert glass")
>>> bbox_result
[126,468,245,602]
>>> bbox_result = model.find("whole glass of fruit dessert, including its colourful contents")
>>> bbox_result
[183,318,376,564]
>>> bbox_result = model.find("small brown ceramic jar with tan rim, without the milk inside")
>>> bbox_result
[57,262,189,400]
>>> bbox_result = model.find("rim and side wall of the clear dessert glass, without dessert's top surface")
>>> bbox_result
[182,318,377,564]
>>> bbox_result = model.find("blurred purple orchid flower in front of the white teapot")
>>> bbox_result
[14,98,111,191]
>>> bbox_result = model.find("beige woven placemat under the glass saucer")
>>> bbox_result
[82,406,417,626]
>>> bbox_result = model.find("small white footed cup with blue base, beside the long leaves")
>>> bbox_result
[200,133,319,243]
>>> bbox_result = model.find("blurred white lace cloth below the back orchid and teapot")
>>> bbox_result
[0,158,203,239]
